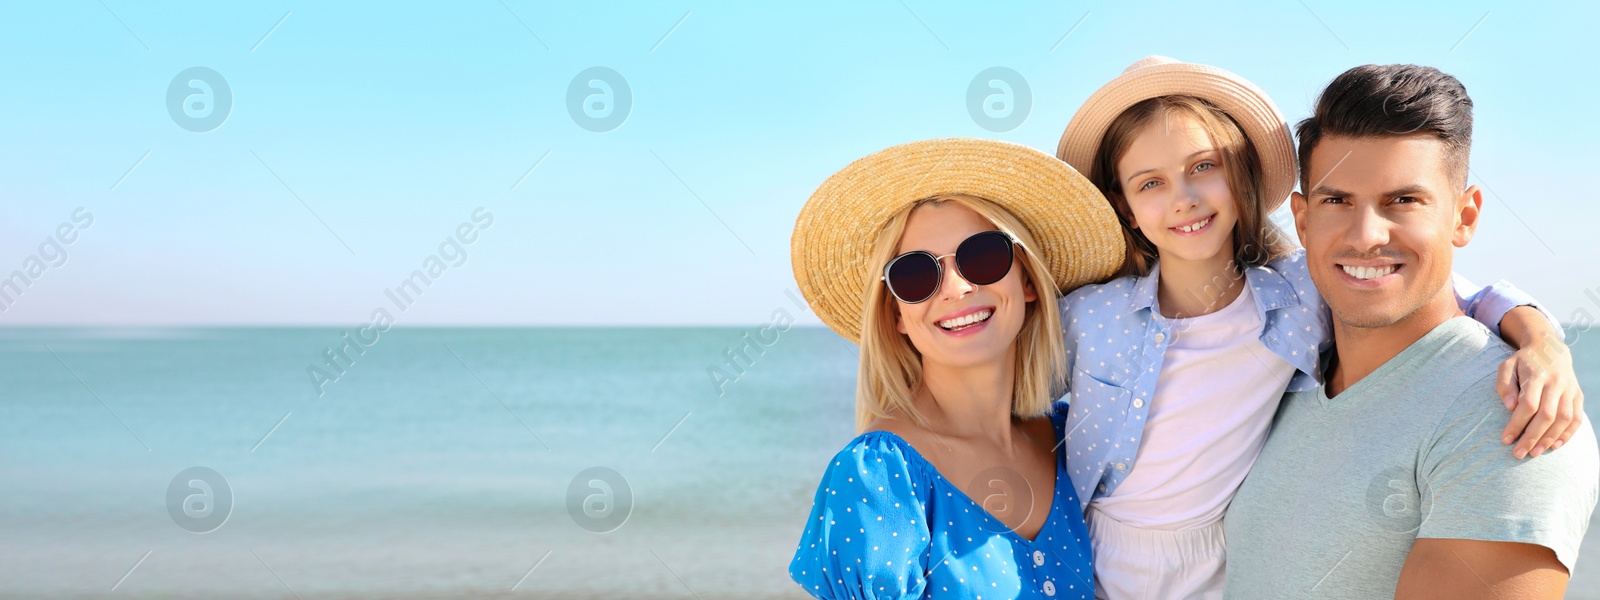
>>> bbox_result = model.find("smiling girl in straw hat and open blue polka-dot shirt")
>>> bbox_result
[1058,56,1578,598]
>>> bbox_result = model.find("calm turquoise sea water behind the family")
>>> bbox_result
[0,326,1600,600]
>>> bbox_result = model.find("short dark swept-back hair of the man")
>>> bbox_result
[1294,64,1472,194]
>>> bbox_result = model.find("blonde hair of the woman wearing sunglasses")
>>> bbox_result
[856,195,1067,432]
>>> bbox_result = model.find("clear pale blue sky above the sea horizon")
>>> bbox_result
[0,0,1600,326]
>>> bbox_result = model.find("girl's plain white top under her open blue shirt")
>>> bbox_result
[1091,285,1294,530]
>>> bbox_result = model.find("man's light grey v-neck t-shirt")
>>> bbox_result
[1224,317,1600,598]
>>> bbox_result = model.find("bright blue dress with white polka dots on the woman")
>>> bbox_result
[789,403,1094,598]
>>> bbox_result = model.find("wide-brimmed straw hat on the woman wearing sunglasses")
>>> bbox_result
[789,138,1125,342]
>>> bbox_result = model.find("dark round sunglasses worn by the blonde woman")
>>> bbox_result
[883,230,1021,304]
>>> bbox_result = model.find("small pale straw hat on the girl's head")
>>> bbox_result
[1056,56,1296,213]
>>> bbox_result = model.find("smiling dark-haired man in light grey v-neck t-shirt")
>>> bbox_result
[1226,66,1600,598]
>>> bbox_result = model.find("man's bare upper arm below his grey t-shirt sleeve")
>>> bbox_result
[1395,538,1568,600]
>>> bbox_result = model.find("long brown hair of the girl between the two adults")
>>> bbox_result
[1088,96,1293,277]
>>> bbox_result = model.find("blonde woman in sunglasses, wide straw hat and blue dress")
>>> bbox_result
[789,139,1122,598]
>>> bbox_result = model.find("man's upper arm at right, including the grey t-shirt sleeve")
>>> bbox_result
[1414,376,1600,598]
